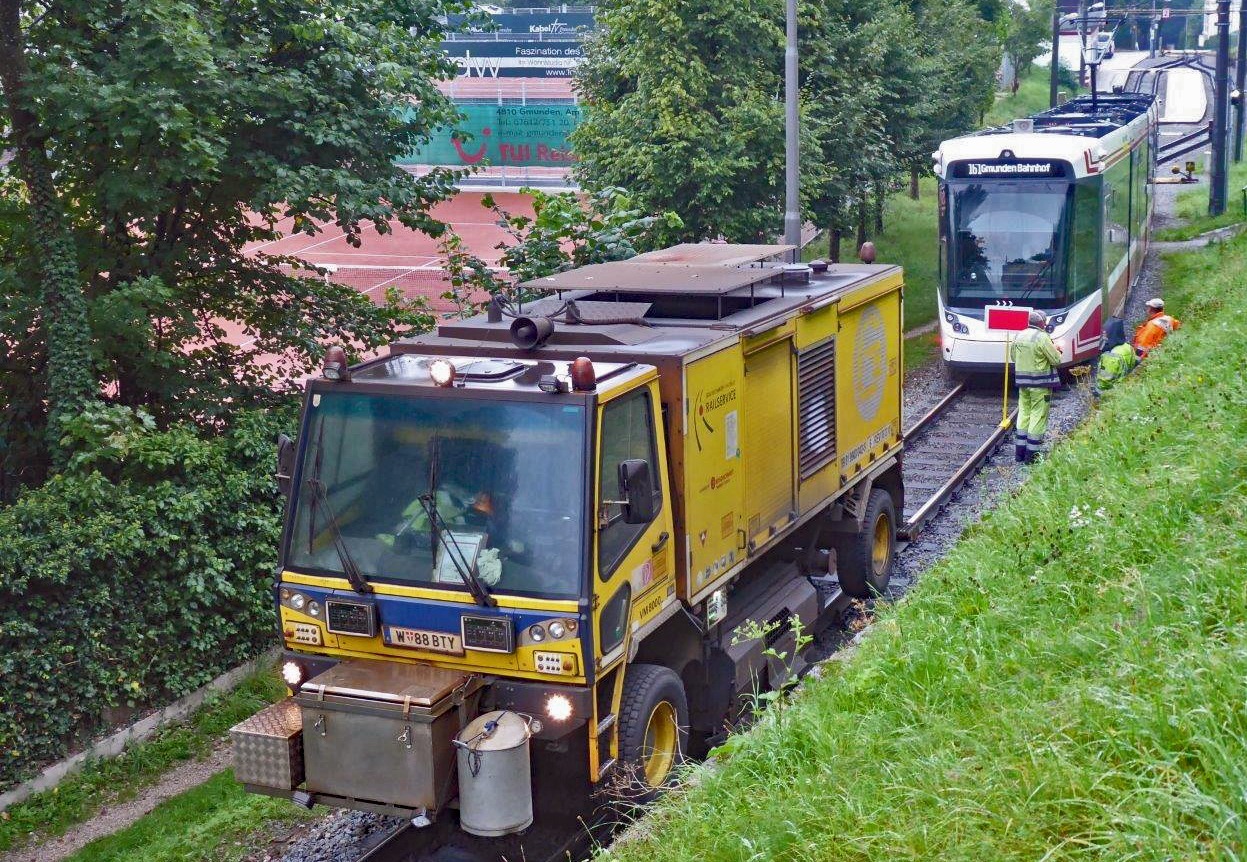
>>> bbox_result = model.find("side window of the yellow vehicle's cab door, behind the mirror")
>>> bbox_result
[597,389,662,580]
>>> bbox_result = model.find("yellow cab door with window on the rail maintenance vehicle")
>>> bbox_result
[594,377,676,671]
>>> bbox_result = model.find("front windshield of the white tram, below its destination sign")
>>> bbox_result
[945,182,1074,308]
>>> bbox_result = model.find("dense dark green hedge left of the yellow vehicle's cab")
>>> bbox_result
[0,408,291,791]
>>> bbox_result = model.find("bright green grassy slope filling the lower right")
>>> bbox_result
[607,237,1247,862]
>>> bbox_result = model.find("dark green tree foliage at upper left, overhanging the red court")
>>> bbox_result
[0,0,468,489]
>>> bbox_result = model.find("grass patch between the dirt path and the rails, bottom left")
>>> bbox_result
[69,770,322,862]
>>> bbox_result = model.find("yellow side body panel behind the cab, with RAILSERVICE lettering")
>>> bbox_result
[673,268,903,600]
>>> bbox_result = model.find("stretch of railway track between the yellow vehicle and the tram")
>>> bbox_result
[897,382,1018,540]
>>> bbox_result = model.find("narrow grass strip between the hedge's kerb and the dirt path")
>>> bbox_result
[0,670,286,851]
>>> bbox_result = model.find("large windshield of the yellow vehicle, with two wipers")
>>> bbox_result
[286,393,586,599]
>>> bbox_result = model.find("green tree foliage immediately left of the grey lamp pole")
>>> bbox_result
[572,0,783,243]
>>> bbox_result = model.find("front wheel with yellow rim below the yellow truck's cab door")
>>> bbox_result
[619,665,688,802]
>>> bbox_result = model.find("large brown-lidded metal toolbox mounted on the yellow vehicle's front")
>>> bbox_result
[294,659,480,812]
